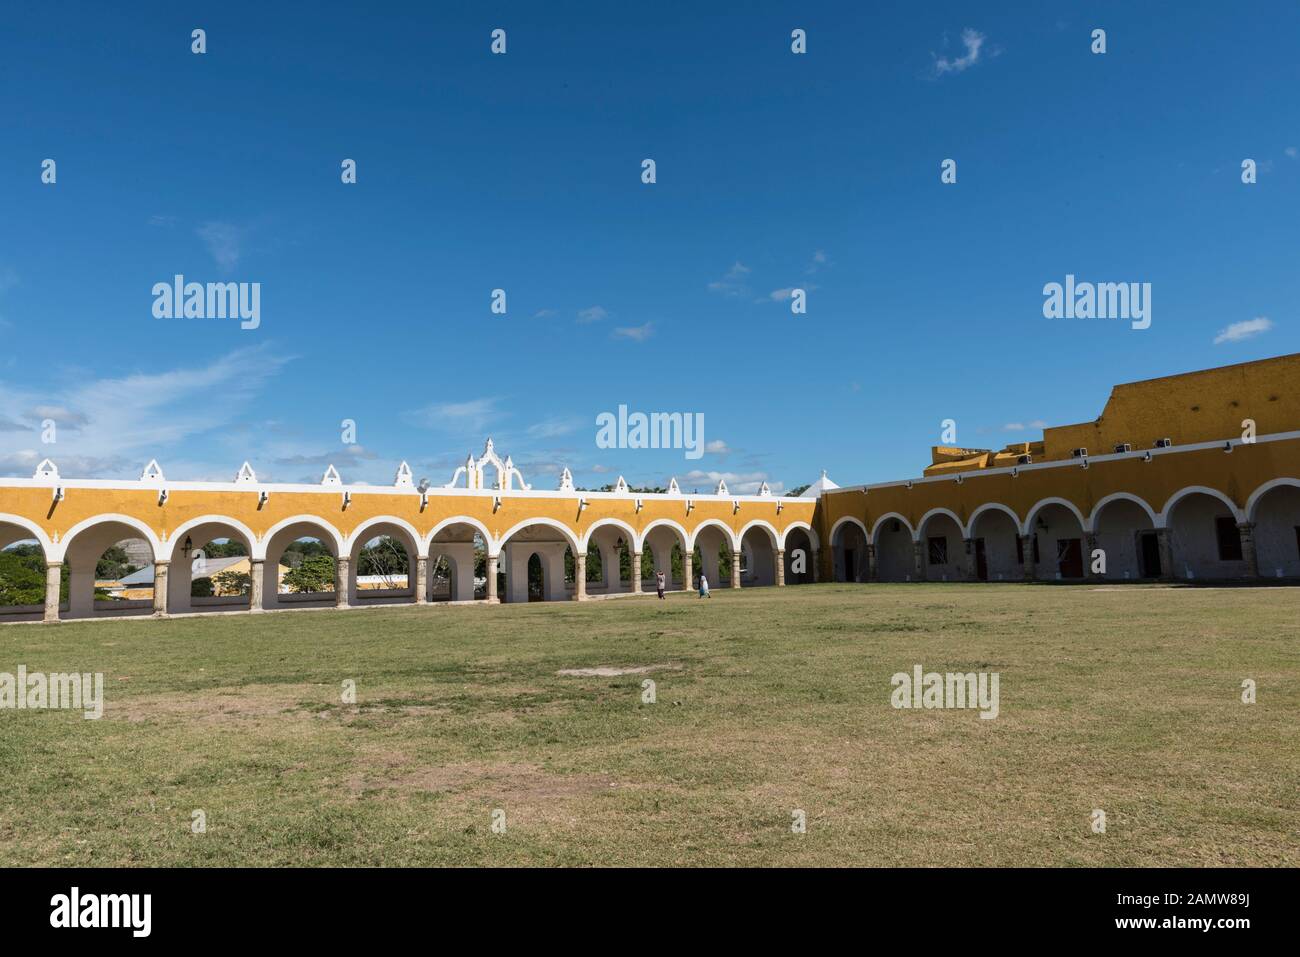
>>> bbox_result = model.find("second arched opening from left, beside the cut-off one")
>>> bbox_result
[64,519,157,619]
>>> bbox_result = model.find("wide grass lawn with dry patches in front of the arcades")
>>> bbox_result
[0,584,1300,866]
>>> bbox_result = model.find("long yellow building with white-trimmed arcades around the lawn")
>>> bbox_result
[0,355,1300,620]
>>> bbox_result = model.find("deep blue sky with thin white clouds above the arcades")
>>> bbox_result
[0,3,1300,492]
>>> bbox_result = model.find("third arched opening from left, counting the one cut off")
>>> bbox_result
[166,519,252,615]
